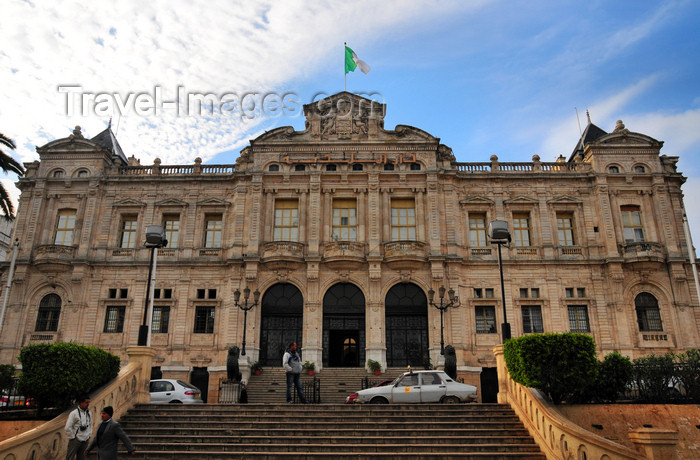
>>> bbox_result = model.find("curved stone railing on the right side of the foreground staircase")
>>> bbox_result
[493,345,652,460]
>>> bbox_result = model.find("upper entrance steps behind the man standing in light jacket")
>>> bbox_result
[248,367,406,404]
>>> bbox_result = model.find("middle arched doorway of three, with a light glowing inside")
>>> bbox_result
[323,283,365,367]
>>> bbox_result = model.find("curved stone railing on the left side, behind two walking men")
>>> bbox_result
[0,347,155,460]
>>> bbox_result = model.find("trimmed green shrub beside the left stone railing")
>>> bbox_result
[19,342,119,410]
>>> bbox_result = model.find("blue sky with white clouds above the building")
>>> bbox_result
[0,0,700,245]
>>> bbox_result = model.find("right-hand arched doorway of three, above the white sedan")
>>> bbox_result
[384,283,429,368]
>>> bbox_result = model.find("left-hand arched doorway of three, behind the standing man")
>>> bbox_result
[259,283,304,367]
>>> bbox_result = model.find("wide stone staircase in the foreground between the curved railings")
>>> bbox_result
[120,403,545,460]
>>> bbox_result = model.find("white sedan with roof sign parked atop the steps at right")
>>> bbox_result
[357,371,477,404]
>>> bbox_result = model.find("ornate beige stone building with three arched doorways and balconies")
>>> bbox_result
[0,92,700,398]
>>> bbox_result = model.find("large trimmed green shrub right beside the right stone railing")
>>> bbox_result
[503,333,598,404]
